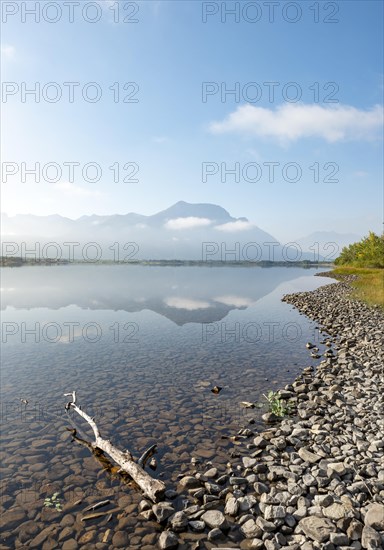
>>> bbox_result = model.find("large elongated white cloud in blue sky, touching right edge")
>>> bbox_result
[209,103,383,143]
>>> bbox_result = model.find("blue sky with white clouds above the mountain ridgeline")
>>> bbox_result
[1,0,383,241]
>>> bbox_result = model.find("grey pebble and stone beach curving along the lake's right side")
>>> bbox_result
[144,278,384,550]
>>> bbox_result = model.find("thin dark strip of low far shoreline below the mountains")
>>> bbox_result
[0,256,334,269]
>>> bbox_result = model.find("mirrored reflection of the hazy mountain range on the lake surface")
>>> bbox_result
[1,265,322,326]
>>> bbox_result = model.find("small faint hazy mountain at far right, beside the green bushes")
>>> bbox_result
[295,231,363,260]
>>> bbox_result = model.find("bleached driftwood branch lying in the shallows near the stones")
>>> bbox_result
[64,391,165,502]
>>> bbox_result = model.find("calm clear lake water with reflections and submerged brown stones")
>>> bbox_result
[1,265,331,548]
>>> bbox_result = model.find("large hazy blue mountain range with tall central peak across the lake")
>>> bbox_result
[1,201,320,261]
